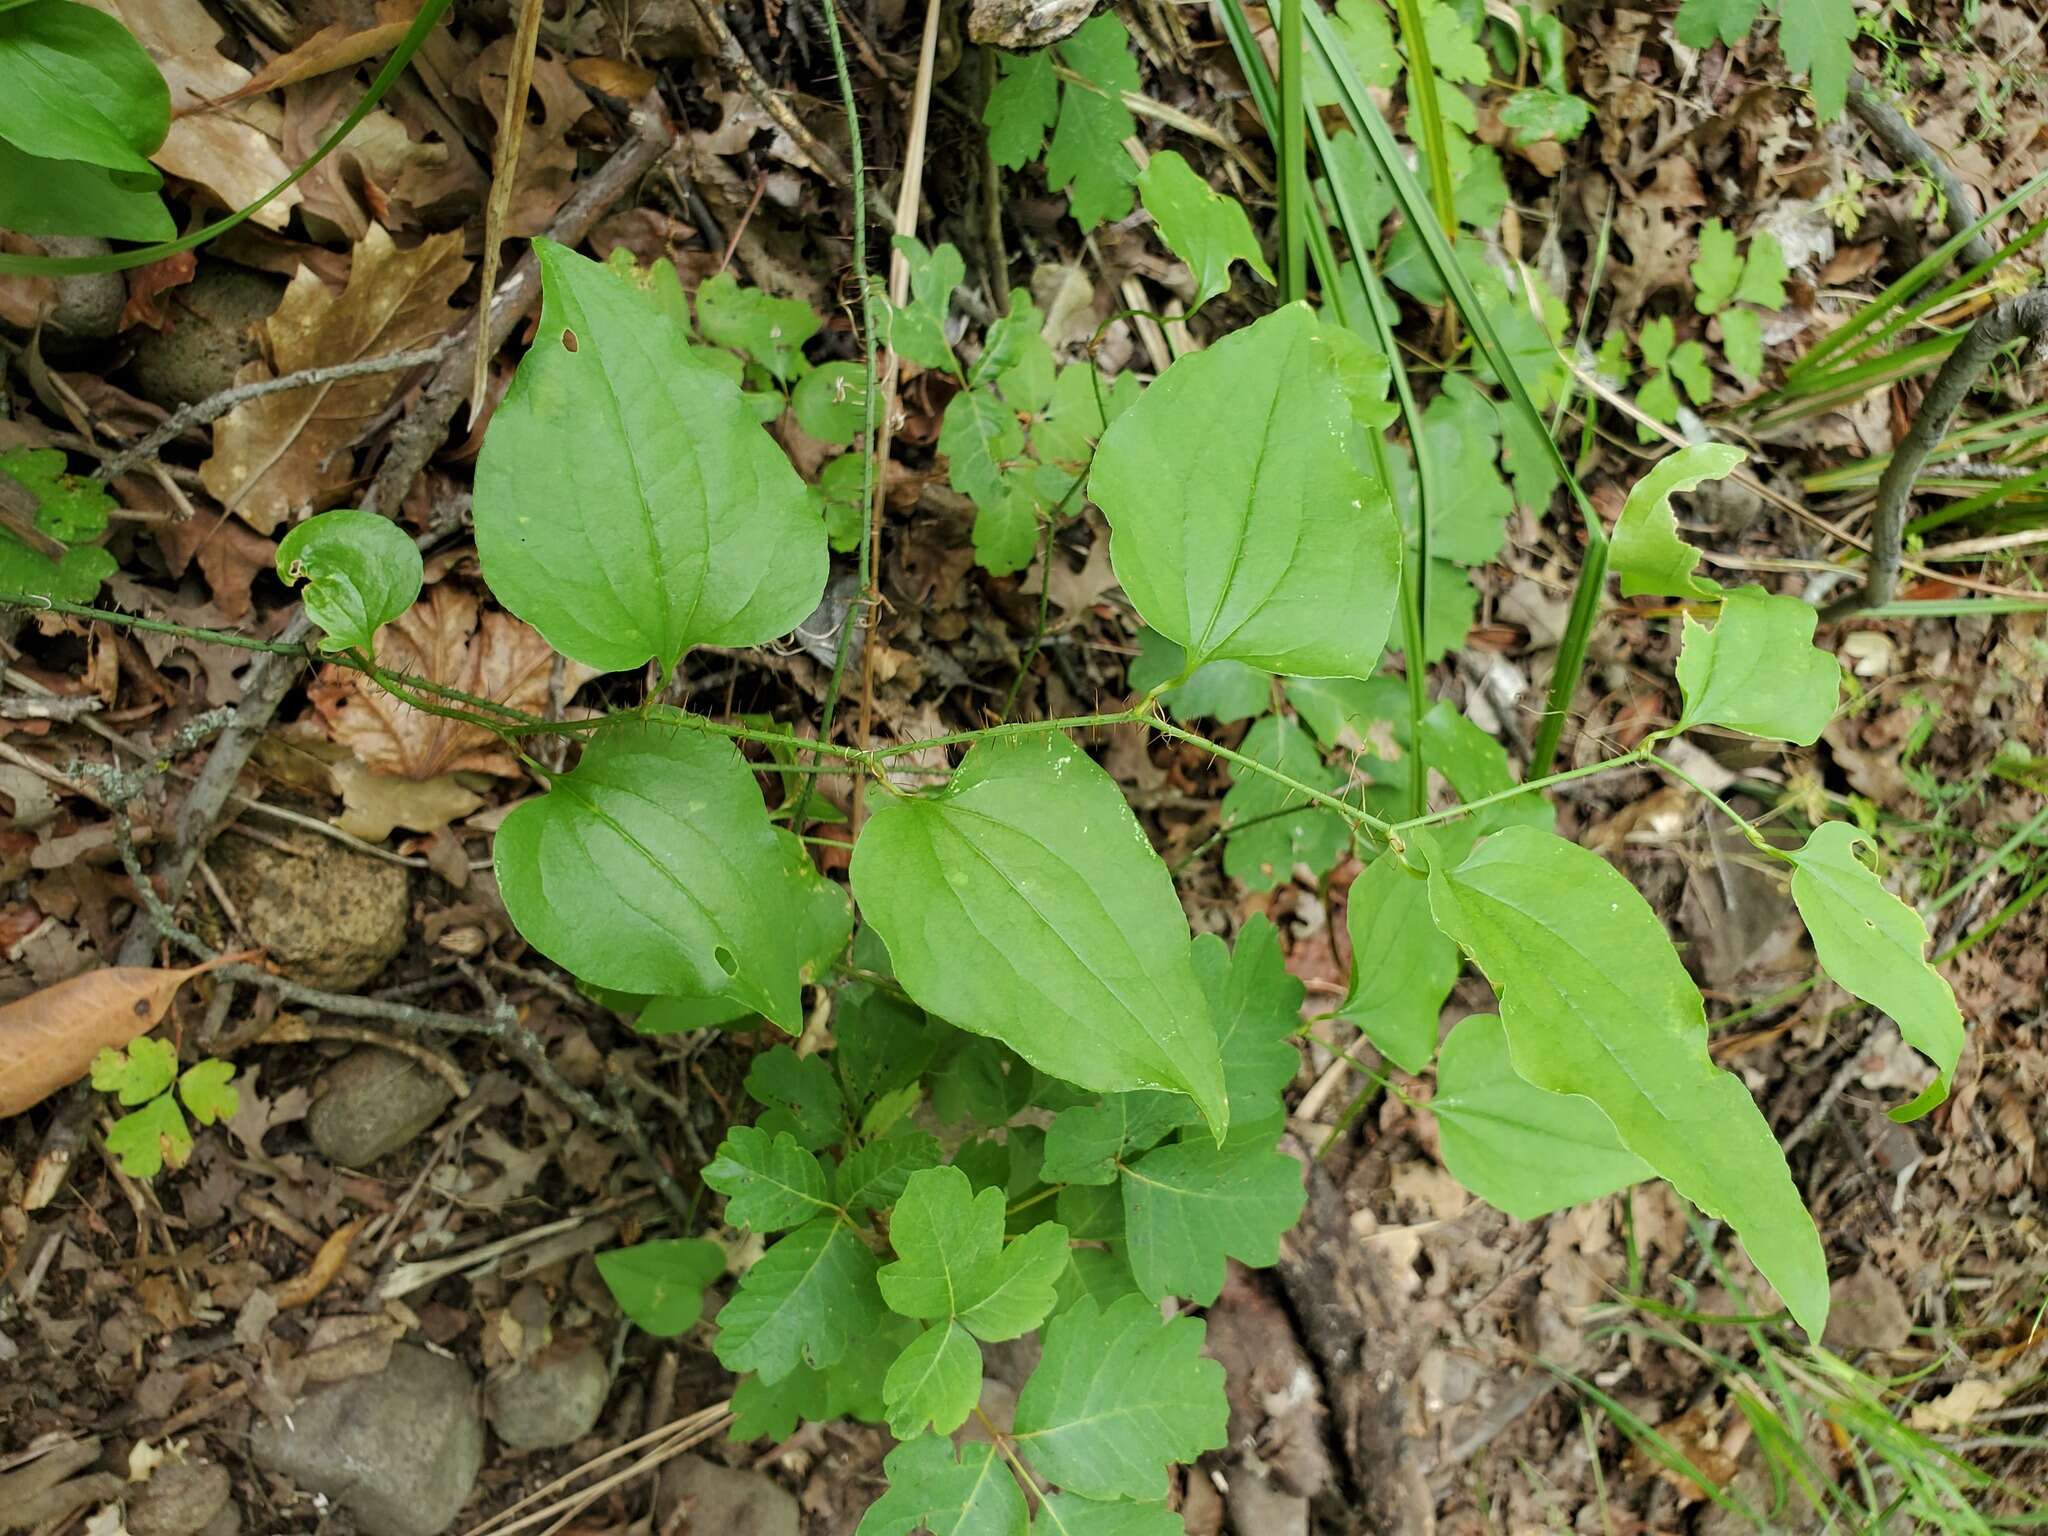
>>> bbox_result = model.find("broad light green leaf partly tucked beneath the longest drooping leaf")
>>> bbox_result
[1430,1014,1657,1221]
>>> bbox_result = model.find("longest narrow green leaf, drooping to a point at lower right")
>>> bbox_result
[1415,827,1827,1337]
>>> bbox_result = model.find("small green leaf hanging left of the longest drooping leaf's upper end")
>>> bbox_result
[1341,852,1462,1073]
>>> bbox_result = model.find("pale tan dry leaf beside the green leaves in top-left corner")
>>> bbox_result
[86,0,299,229]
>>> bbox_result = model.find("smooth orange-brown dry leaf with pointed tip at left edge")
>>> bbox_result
[0,954,252,1118]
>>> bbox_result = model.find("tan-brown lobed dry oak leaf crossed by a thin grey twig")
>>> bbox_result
[199,225,469,532]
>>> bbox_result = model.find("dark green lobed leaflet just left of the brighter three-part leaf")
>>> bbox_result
[715,1217,887,1382]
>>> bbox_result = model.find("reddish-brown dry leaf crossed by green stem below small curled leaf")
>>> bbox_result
[313,582,598,778]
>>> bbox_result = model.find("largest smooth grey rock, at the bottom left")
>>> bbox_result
[250,1343,483,1536]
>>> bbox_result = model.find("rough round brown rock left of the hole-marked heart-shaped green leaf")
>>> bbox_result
[211,838,412,991]
